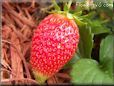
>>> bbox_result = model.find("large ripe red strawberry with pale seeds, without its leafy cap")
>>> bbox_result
[30,14,79,82]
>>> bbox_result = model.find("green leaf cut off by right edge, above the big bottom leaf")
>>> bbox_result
[100,35,114,77]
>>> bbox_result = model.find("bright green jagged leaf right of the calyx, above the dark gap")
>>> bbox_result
[81,16,111,35]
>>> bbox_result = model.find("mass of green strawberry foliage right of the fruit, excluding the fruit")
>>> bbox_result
[71,2,114,84]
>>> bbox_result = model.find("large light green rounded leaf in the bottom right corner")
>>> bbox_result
[71,59,113,84]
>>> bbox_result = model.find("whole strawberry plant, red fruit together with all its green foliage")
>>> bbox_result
[30,0,114,84]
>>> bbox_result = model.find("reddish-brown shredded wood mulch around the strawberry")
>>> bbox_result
[1,1,71,84]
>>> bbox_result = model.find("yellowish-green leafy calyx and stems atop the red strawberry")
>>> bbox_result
[49,0,86,26]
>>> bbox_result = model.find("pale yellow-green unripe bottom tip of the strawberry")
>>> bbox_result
[33,70,48,84]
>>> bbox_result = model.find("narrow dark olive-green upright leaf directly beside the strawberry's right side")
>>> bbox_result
[79,26,93,58]
